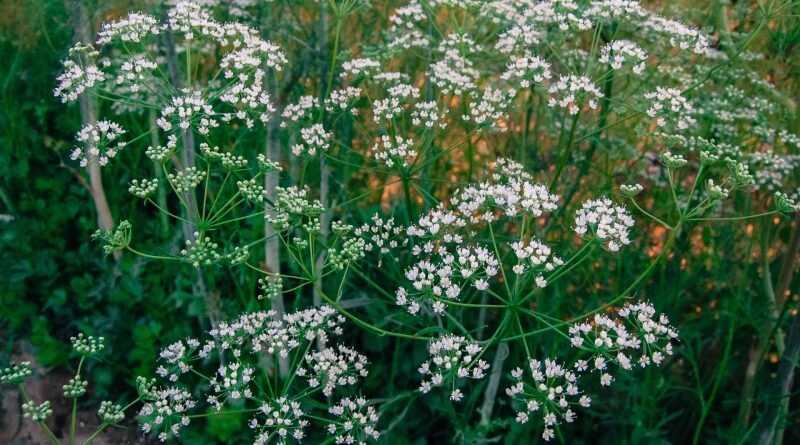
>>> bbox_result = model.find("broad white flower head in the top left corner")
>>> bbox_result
[54,1,287,168]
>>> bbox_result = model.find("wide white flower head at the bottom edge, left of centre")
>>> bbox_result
[139,306,379,444]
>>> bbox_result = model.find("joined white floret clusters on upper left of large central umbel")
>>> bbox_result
[395,159,563,315]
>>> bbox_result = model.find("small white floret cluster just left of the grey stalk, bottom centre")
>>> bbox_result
[418,335,489,402]
